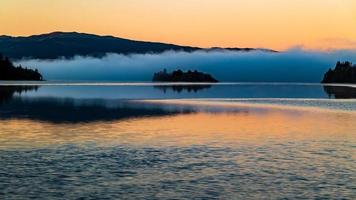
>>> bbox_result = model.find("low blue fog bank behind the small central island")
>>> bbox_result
[17,49,356,82]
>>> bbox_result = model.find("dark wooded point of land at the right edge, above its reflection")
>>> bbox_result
[321,61,356,83]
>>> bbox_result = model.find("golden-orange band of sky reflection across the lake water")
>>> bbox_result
[0,103,356,149]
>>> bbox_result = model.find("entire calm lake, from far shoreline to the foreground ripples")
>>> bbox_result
[0,82,356,199]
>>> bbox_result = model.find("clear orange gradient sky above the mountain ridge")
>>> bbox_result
[0,0,356,50]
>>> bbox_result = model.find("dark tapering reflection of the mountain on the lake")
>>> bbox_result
[0,98,193,123]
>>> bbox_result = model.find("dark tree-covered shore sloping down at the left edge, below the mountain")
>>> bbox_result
[0,54,43,81]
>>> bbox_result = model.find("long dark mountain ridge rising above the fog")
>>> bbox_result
[0,32,273,59]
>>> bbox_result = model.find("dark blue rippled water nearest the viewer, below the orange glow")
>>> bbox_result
[0,141,356,199]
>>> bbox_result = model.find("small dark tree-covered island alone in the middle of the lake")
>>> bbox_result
[152,69,219,83]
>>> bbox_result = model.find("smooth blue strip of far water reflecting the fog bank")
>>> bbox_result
[0,82,356,99]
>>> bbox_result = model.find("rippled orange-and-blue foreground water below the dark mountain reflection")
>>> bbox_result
[0,103,356,199]
